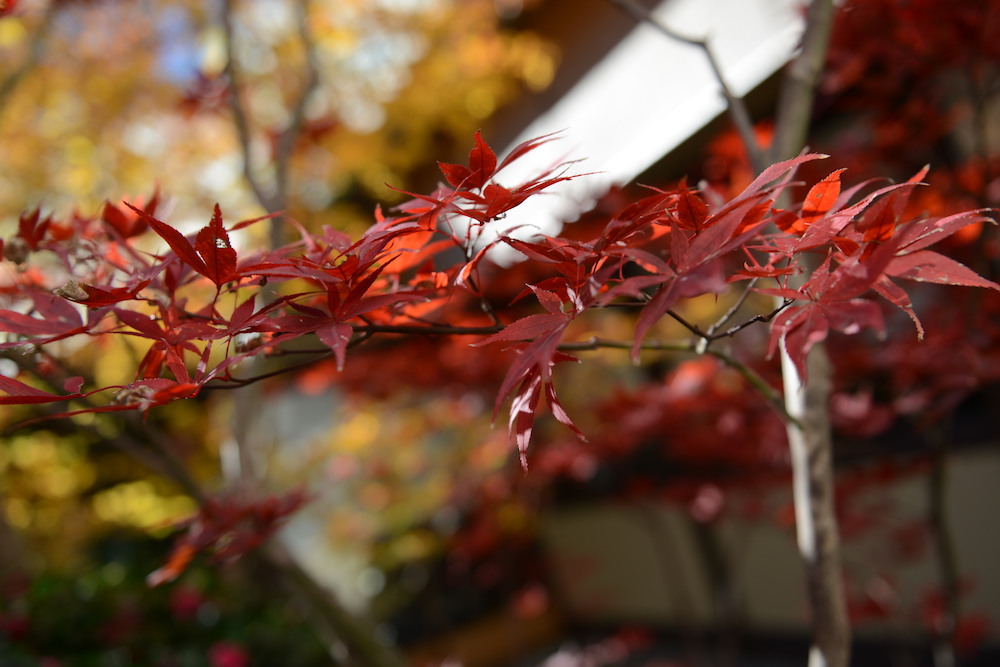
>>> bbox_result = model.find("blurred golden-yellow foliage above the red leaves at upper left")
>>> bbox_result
[0,0,557,235]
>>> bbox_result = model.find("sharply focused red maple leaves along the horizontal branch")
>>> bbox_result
[0,133,1000,470]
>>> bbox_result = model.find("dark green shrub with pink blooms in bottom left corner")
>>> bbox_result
[0,534,328,667]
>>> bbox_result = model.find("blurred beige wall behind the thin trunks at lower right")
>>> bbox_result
[543,447,1000,637]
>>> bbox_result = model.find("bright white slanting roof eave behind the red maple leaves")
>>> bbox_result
[488,0,804,250]
